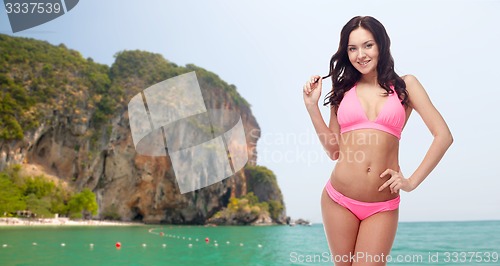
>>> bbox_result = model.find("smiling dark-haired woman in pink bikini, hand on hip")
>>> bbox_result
[303,16,453,265]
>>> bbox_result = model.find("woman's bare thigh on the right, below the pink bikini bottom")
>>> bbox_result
[353,210,399,265]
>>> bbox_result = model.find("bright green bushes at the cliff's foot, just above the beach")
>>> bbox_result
[0,166,97,218]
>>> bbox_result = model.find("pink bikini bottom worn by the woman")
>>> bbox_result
[325,180,400,221]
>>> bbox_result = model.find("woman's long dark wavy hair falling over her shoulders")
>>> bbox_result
[323,16,408,108]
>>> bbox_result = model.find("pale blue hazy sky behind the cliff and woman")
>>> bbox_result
[0,0,500,223]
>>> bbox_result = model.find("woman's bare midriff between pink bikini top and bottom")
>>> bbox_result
[330,129,399,202]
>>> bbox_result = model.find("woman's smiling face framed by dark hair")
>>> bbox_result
[347,27,379,76]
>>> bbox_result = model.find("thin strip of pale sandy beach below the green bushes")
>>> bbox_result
[0,217,145,227]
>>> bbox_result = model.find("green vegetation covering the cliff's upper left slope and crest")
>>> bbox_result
[0,34,249,140]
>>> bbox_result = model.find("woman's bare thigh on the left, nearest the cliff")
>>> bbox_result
[321,189,359,265]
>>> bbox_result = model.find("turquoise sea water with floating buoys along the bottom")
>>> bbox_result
[0,221,500,266]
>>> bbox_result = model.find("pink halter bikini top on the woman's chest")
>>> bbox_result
[337,84,406,139]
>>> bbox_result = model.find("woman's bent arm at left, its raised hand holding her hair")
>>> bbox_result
[303,76,340,160]
